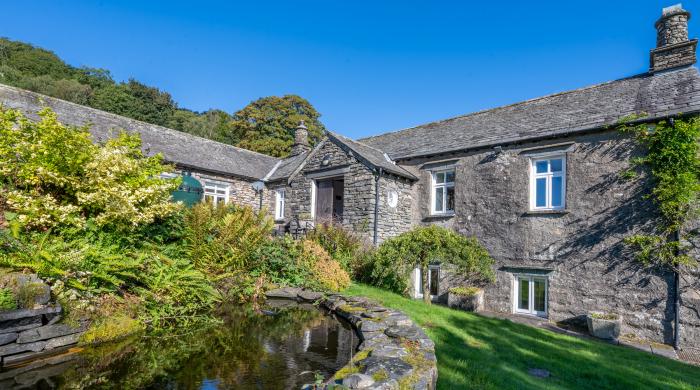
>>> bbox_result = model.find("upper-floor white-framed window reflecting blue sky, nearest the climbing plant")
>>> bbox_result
[530,154,566,210]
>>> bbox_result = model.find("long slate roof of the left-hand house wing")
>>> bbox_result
[0,84,280,180]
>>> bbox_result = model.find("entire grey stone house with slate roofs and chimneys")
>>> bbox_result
[0,6,700,346]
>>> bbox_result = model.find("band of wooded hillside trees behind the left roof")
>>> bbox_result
[0,38,324,156]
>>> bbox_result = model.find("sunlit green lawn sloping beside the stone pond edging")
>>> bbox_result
[345,284,700,389]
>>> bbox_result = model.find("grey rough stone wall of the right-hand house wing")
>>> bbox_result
[396,131,700,344]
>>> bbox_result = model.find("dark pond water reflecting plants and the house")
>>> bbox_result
[0,301,358,389]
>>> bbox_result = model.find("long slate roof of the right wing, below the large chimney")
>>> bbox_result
[360,67,700,160]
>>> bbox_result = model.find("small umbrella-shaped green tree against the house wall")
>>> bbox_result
[372,225,494,304]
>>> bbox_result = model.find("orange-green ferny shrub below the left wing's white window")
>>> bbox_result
[186,203,274,276]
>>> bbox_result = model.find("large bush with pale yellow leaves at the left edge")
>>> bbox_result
[0,107,181,230]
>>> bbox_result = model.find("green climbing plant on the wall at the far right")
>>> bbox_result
[619,117,700,270]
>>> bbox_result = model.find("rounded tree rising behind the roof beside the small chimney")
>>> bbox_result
[233,95,325,157]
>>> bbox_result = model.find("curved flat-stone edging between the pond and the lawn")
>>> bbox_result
[265,287,437,390]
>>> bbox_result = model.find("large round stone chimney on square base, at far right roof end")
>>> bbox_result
[649,4,698,73]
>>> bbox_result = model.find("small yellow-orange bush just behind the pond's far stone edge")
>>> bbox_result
[298,240,350,291]
